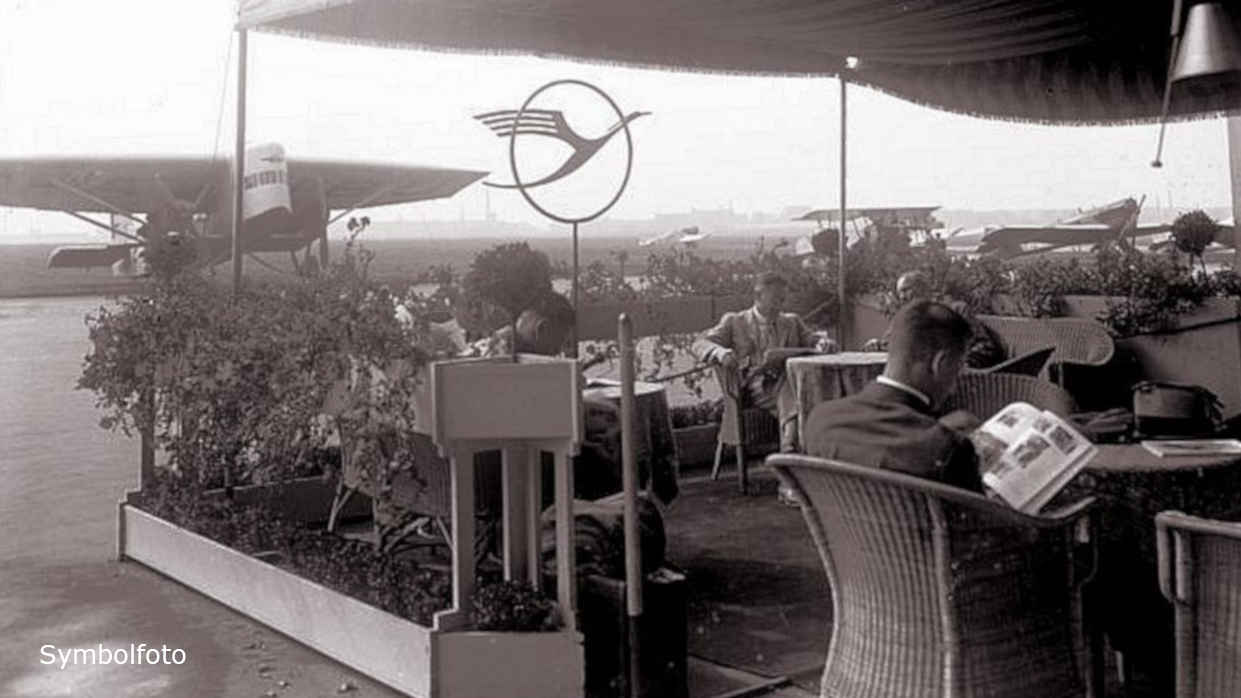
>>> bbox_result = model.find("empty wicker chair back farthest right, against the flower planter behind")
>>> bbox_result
[978,315,1116,388]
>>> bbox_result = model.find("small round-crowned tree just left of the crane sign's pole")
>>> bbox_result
[465,242,552,360]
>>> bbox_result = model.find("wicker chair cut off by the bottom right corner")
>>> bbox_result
[1155,512,1241,698]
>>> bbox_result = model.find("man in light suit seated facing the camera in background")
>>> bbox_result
[694,272,815,452]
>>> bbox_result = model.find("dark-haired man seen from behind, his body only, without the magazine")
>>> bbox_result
[805,301,983,492]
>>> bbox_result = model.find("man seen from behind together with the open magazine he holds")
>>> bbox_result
[805,301,1096,513]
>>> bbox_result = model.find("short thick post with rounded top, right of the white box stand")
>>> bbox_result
[617,313,643,698]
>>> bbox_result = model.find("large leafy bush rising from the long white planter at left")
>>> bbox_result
[78,244,429,494]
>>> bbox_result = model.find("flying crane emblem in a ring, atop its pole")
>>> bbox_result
[474,79,650,224]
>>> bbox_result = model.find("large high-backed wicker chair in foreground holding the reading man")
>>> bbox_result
[767,455,1102,698]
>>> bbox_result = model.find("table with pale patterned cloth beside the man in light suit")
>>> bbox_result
[784,351,887,443]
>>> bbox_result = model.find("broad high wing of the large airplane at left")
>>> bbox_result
[0,156,486,214]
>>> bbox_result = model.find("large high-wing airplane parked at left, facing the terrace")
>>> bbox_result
[0,143,486,276]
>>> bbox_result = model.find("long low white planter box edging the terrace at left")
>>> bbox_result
[117,503,585,698]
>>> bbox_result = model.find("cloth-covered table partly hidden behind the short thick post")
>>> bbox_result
[582,379,680,504]
